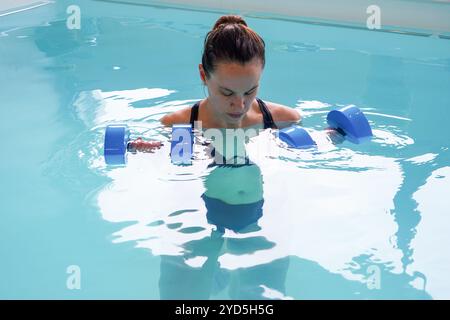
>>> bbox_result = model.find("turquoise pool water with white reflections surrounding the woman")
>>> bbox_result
[0,1,450,299]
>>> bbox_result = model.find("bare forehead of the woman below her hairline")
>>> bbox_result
[211,59,262,89]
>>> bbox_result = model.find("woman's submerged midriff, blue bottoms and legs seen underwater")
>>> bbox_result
[159,164,289,299]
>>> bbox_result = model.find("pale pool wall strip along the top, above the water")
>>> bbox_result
[96,0,450,37]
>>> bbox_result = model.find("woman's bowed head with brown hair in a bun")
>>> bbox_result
[199,16,265,123]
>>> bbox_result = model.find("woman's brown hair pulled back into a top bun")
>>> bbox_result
[202,15,266,78]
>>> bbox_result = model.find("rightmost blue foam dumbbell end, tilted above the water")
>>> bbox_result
[327,106,373,144]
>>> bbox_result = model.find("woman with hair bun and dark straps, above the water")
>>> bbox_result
[130,15,300,152]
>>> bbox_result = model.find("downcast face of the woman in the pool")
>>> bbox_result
[199,58,263,125]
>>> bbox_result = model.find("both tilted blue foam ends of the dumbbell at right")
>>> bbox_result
[278,106,373,149]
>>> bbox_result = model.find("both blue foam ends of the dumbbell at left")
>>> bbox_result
[104,124,194,165]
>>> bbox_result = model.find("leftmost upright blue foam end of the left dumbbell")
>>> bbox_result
[104,125,130,165]
